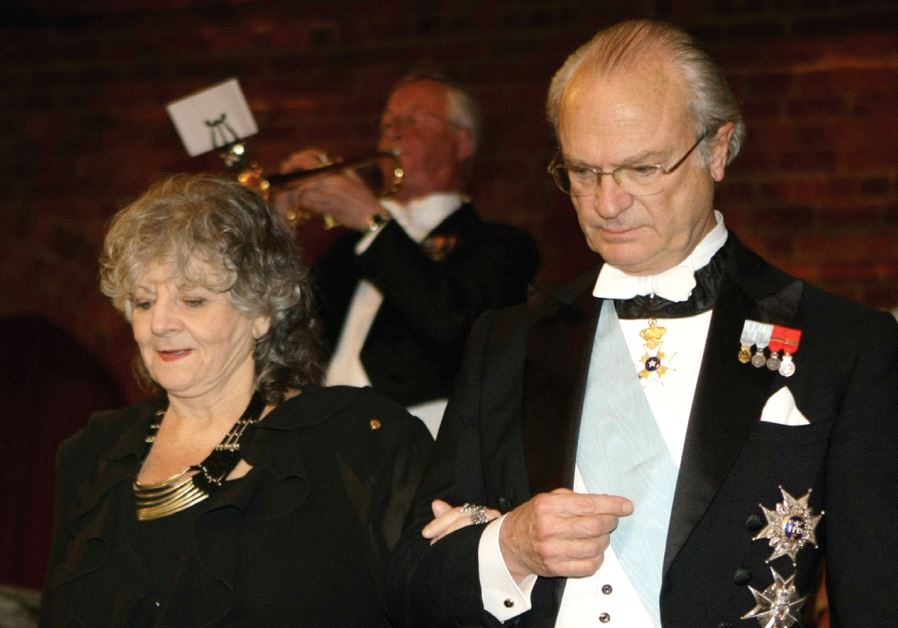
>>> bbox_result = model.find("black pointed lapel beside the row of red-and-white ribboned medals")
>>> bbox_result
[664,234,802,573]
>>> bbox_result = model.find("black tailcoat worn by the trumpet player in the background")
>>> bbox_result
[315,204,538,406]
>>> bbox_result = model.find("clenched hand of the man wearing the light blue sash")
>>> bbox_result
[499,488,633,583]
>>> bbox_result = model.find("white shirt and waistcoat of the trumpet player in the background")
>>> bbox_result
[324,192,463,437]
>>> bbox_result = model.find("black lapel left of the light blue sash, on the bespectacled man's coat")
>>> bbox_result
[521,271,601,495]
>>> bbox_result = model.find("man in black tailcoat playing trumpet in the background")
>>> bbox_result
[274,74,538,435]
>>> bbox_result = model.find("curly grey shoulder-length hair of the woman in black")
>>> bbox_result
[100,174,322,403]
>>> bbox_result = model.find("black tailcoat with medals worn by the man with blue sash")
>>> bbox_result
[388,234,898,628]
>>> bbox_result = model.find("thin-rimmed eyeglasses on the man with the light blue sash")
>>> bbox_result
[548,133,708,197]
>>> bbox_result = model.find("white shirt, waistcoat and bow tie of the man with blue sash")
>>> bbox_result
[478,212,727,628]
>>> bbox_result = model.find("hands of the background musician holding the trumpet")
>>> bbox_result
[273,148,383,231]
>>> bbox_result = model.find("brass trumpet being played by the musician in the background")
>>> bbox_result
[222,142,405,229]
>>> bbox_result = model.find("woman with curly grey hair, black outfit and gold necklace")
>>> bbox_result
[41,175,430,628]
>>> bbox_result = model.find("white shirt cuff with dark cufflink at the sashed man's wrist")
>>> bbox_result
[477,515,536,622]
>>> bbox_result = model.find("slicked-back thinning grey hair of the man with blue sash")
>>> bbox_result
[546,20,745,163]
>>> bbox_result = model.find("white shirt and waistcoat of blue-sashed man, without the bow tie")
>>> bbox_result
[478,214,735,628]
